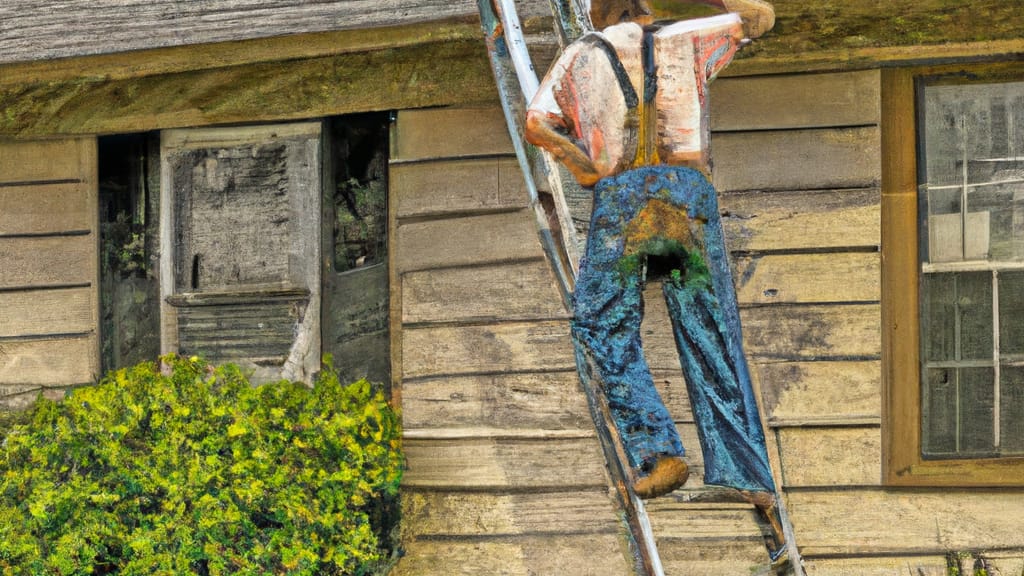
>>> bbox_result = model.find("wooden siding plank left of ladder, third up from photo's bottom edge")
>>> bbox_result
[402,438,608,491]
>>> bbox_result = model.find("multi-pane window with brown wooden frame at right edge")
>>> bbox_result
[883,67,1024,485]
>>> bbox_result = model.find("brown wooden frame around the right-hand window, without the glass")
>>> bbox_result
[881,63,1024,487]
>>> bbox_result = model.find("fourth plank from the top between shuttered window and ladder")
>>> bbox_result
[402,260,568,323]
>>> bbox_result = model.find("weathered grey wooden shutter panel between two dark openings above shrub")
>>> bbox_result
[161,122,322,381]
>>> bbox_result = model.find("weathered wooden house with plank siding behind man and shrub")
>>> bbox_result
[0,0,1024,576]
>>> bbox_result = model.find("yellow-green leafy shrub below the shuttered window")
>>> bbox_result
[0,356,402,576]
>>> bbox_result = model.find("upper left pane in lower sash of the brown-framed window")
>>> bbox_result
[921,272,992,362]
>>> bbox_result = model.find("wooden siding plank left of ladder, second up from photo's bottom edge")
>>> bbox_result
[401,489,625,537]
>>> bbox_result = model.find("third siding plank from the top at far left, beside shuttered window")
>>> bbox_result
[0,235,96,288]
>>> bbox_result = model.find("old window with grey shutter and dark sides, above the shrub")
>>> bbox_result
[93,113,391,390]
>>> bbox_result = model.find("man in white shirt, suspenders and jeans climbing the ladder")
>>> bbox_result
[481,0,785,563]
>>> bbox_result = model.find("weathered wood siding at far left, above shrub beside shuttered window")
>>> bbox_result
[0,138,99,408]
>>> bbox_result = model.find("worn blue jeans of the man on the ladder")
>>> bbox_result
[572,166,775,492]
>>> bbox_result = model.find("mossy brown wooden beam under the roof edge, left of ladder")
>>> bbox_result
[0,38,497,137]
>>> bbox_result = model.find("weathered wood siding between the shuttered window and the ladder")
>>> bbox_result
[389,108,633,576]
